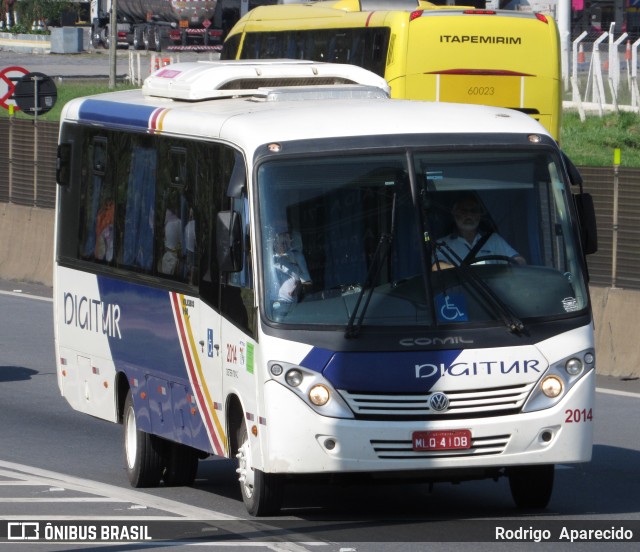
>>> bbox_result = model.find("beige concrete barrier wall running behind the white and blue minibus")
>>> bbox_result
[0,203,640,377]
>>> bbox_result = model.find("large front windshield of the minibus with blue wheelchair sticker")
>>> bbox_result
[257,150,587,329]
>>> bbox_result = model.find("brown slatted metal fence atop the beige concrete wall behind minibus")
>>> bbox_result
[0,118,640,289]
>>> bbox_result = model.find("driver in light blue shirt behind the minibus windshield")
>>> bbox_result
[435,194,526,268]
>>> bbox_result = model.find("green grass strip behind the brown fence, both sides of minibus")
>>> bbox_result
[0,80,640,167]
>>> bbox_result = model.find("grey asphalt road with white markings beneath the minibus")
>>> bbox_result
[0,281,640,552]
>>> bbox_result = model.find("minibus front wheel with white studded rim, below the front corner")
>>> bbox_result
[236,420,284,517]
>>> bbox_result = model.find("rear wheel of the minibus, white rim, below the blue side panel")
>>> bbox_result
[122,391,165,488]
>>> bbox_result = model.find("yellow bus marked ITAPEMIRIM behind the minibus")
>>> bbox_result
[222,0,562,139]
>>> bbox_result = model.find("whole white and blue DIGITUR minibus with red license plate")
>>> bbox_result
[54,60,596,516]
